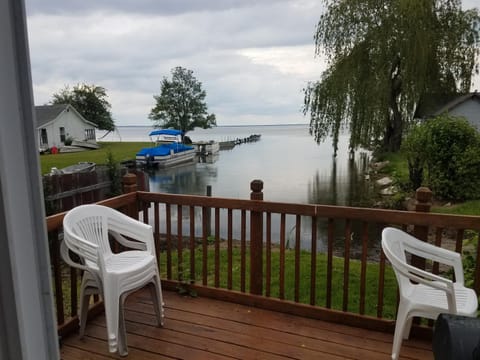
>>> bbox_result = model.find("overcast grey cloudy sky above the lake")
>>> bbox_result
[25,0,479,126]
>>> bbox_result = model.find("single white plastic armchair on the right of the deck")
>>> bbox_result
[382,227,478,360]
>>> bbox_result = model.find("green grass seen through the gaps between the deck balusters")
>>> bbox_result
[159,243,397,319]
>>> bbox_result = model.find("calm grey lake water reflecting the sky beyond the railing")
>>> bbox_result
[98,125,376,251]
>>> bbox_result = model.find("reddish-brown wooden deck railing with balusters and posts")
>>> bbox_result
[47,176,480,333]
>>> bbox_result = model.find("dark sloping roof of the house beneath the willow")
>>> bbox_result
[415,92,480,118]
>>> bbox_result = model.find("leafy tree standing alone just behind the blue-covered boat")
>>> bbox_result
[149,66,216,134]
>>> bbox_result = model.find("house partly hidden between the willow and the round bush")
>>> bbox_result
[416,92,480,131]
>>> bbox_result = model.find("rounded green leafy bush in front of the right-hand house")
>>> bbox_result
[403,115,480,200]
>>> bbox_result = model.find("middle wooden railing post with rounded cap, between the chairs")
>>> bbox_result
[250,180,263,295]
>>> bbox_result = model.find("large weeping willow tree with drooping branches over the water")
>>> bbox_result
[303,0,480,151]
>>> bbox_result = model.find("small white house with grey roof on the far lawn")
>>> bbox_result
[35,104,96,150]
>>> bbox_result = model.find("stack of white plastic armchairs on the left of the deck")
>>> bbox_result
[61,205,164,356]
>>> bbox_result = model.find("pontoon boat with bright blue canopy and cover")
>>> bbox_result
[135,129,196,168]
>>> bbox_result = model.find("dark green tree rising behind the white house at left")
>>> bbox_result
[51,84,115,131]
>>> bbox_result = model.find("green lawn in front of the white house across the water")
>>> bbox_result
[40,142,152,174]
